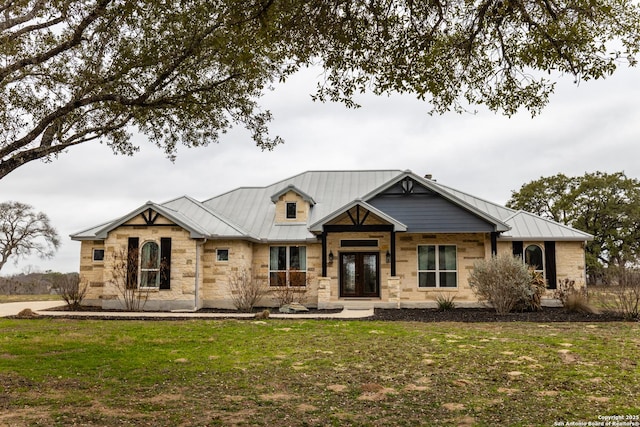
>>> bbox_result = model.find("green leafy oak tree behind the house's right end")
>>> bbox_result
[507,172,640,280]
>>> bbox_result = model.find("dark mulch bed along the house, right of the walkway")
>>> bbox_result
[367,307,624,323]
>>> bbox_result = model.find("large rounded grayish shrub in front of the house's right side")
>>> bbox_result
[469,255,536,314]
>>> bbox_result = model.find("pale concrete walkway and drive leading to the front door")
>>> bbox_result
[0,301,373,319]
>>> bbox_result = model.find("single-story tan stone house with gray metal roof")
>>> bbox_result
[71,170,592,310]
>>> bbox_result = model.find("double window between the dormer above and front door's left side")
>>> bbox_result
[269,246,307,286]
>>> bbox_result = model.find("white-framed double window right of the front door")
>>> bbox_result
[418,245,458,288]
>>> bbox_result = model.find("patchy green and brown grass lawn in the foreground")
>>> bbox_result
[0,319,640,426]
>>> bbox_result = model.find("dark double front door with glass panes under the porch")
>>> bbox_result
[340,252,380,297]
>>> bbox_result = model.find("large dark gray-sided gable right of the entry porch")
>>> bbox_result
[368,179,496,233]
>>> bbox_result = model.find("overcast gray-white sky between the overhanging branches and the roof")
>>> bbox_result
[0,68,640,275]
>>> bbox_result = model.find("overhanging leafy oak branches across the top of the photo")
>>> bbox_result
[0,0,640,178]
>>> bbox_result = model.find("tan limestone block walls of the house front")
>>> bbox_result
[80,224,585,310]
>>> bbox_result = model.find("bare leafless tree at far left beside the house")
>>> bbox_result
[0,202,60,270]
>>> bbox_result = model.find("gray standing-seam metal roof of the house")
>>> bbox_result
[71,170,592,242]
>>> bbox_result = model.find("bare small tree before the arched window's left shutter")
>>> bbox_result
[108,248,150,311]
